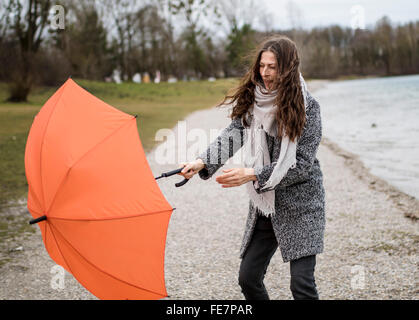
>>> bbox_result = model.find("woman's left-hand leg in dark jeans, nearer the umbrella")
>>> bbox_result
[239,217,278,300]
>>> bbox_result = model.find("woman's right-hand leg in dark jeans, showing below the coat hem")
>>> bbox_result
[290,255,319,300]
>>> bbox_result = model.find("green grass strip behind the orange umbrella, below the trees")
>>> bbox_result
[0,79,237,212]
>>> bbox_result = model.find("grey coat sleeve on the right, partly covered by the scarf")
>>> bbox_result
[254,96,322,193]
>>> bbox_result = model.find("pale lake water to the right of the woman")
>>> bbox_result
[313,75,419,199]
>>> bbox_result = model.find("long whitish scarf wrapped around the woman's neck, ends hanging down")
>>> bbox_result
[243,74,307,216]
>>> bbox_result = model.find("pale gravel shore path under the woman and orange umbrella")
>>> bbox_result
[0,81,419,300]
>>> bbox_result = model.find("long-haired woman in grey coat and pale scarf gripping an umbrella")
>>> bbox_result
[181,36,325,299]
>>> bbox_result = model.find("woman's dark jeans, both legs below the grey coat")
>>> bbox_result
[239,217,319,300]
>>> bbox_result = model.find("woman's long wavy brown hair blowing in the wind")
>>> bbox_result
[219,36,306,141]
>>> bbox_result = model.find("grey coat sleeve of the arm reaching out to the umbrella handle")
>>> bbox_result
[198,119,244,180]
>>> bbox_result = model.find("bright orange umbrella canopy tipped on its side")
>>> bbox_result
[25,79,173,299]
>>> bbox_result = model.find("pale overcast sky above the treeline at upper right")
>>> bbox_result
[257,0,419,29]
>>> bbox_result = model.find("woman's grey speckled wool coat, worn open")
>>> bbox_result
[198,93,325,262]
